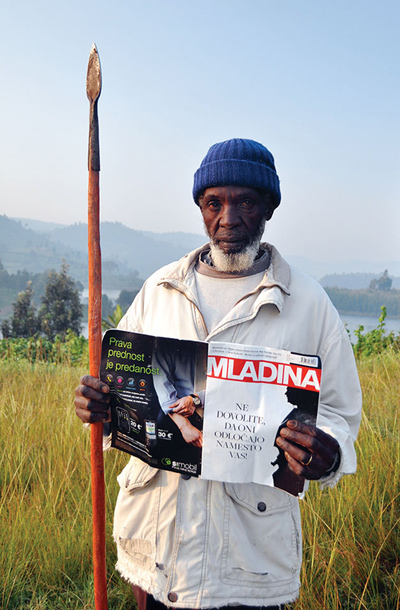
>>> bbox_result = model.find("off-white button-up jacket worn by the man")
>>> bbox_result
[114,241,361,608]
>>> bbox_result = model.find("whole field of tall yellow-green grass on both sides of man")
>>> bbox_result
[0,352,400,610]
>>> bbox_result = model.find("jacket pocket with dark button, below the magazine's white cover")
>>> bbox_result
[221,483,301,587]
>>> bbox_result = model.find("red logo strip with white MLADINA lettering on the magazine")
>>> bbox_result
[207,356,321,392]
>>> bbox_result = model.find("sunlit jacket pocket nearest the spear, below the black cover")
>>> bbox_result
[114,458,160,571]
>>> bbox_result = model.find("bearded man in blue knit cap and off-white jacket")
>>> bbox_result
[76,139,360,610]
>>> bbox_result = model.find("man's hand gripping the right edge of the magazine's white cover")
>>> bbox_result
[276,419,339,480]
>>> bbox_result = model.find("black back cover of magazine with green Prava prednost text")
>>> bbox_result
[100,330,208,476]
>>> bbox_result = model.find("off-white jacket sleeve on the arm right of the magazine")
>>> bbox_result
[317,324,362,487]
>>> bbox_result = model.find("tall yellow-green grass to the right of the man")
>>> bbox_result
[296,351,400,610]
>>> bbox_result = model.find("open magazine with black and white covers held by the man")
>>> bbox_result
[100,330,321,495]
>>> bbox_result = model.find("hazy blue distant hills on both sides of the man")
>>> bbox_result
[4,216,400,289]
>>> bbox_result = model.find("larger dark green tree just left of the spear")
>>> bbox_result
[39,261,82,340]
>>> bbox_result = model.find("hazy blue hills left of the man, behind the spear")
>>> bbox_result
[0,216,206,289]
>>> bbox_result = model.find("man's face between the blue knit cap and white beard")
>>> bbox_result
[199,186,272,254]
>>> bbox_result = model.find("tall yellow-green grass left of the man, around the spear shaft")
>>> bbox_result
[0,363,133,610]
